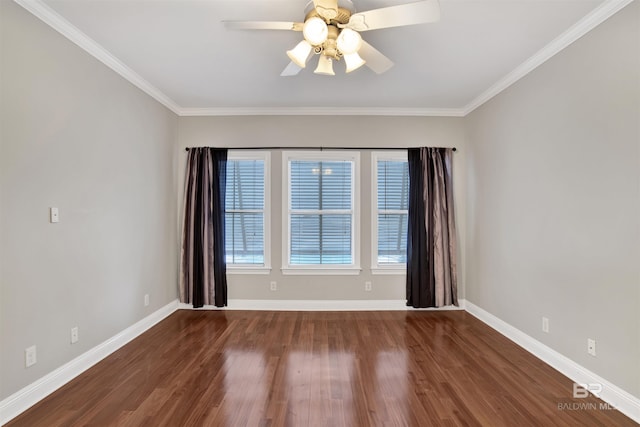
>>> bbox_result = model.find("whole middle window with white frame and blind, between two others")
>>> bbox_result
[283,152,360,274]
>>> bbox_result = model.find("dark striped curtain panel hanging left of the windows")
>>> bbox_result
[180,147,227,308]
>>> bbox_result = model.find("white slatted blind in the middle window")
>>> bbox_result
[288,159,355,266]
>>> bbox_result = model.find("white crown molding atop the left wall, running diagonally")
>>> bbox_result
[14,0,180,114]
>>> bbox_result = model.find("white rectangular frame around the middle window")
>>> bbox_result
[282,150,361,275]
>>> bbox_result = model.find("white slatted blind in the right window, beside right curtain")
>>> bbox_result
[375,159,409,266]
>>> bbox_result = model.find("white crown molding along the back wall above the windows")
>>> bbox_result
[177,107,464,117]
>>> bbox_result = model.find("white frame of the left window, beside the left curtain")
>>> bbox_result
[225,149,271,274]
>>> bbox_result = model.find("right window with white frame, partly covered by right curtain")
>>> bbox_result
[371,151,409,274]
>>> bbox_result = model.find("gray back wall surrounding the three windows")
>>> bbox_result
[178,116,466,300]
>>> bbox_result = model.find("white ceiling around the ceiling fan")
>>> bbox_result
[16,0,630,116]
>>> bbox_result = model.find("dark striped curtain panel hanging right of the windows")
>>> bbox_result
[407,147,458,308]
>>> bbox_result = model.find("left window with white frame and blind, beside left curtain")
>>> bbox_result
[225,151,270,273]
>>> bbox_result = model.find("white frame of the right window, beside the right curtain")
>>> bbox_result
[371,150,409,275]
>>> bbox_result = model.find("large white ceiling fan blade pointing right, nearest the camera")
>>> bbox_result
[345,0,440,31]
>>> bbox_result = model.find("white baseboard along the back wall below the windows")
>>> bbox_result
[179,299,464,311]
